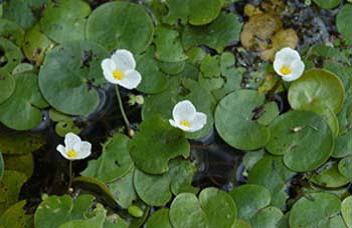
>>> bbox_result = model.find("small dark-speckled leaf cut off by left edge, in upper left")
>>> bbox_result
[0,38,22,72]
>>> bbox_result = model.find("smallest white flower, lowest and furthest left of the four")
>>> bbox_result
[56,133,92,160]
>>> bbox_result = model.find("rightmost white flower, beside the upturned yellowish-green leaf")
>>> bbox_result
[274,47,304,82]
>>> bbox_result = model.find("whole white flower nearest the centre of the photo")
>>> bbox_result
[169,100,207,132]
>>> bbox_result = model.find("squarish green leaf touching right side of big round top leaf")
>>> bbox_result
[154,26,187,62]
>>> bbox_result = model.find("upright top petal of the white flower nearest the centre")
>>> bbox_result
[172,100,197,123]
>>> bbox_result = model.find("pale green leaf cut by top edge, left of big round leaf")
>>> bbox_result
[40,0,91,43]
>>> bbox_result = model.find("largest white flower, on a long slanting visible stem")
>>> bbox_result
[101,49,142,89]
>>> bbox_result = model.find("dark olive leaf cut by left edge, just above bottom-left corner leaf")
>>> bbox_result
[0,170,27,215]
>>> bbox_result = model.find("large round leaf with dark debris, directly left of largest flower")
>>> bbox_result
[39,41,108,116]
